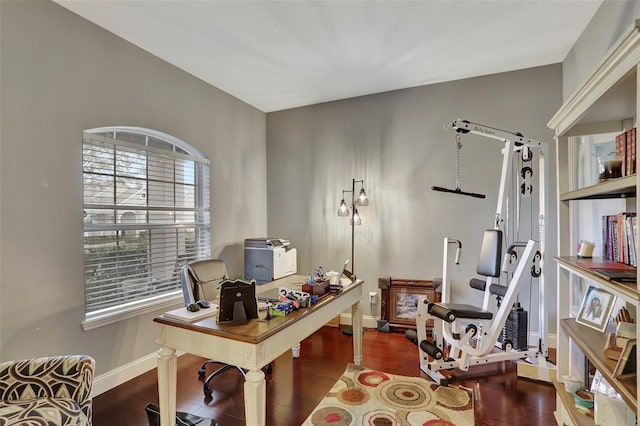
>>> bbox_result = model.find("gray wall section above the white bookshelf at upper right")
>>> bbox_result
[562,0,640,99]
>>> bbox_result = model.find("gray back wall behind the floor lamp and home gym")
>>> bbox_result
[267,64,562,331]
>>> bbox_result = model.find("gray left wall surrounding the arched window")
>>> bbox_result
[0,1,267,374]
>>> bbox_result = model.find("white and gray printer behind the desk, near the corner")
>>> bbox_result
[244,238,298,284]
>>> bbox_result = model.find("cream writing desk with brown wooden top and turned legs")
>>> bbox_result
[153,275,363,426]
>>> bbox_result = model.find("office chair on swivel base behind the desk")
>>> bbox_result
[180,259,246,398]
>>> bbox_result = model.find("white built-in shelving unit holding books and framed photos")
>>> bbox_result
[548,20,640,425]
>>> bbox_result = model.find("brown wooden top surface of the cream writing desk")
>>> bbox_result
[153,276,364,344]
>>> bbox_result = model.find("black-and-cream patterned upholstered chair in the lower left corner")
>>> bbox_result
[0,355,95,426]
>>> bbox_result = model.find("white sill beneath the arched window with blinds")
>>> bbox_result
[81,290,183,331]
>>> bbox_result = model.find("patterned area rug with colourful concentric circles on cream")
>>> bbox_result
[303,364,474,426]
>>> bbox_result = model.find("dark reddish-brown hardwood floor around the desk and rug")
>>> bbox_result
[93,327,556,426]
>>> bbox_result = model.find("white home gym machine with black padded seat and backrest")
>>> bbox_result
[407,119,551,385]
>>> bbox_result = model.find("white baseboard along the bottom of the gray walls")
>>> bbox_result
[91,313,556,397]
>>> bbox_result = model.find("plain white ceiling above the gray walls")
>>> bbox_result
[55,0,602,112]
